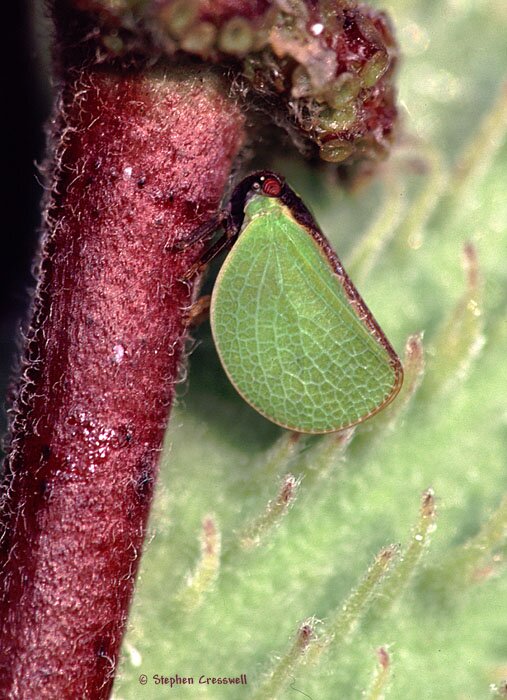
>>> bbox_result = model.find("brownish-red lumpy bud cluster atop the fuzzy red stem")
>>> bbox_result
[69,0,398,169]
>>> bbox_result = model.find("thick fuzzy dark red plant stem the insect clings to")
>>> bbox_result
[0,58,243,699]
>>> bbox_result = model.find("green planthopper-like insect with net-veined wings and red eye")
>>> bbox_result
[184,171,403,433]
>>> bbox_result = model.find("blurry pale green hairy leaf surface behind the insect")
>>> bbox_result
[114,0,507,700]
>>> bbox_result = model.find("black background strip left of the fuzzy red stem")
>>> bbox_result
[0,0,51,433]
